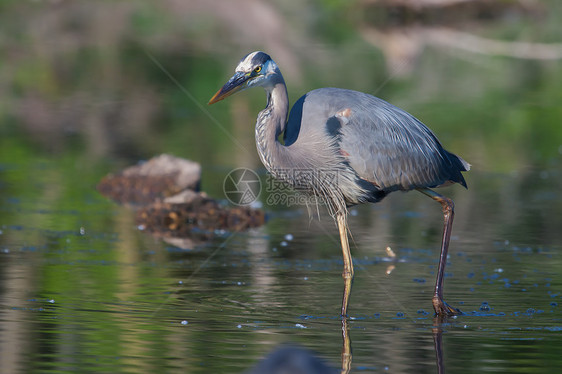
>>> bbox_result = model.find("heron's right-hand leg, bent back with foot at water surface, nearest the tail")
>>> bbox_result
[418,188,462,316]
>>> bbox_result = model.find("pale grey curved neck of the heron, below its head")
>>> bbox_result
[256,77,291,175]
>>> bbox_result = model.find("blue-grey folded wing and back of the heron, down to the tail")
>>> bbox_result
[294,88,470,192]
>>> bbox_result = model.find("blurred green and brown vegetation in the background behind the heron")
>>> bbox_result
[0,0,562,171]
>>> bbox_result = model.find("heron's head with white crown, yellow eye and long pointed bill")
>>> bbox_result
[209,51,281,105]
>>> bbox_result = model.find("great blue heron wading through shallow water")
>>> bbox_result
[209,51,470,318]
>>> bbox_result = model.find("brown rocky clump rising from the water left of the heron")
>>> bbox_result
[97,155,265,241]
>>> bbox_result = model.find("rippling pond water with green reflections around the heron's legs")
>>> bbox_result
[0,161,562,373]
